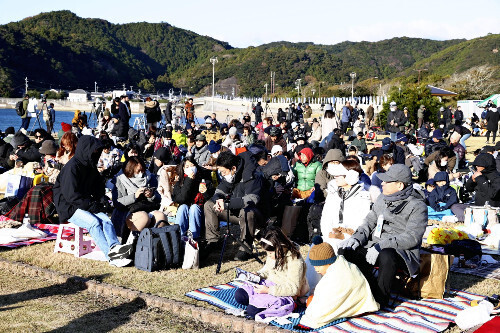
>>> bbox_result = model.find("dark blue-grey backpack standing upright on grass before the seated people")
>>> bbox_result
[134,221,183,272]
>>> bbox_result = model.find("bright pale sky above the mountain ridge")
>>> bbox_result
[0,0,500,47]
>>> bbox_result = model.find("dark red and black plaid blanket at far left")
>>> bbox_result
[6,184,57,224]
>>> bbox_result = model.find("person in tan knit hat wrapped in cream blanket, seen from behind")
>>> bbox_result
[300,237,380,329]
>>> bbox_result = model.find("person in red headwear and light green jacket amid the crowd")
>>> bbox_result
[292,148,322,199]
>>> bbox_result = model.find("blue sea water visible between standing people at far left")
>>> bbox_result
[0,109,147,133]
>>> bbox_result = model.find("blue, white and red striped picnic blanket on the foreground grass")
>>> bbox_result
[186,281,484,333]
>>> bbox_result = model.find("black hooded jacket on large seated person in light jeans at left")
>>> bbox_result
[53,135,104,223]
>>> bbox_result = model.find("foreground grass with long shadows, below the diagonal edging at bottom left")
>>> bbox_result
[0,271,221,333]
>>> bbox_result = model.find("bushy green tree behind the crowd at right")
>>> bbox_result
[377,84,444,128]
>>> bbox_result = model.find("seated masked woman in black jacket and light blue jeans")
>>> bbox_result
[172,156,212,239]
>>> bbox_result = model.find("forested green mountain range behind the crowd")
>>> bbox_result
[0,11,500,96]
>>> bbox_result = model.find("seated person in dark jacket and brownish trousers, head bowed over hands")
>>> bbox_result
[202,152,267,261]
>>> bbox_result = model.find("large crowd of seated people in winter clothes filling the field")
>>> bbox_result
[0,96,500,327]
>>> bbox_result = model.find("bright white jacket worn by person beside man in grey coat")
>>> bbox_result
[321,179,371,252]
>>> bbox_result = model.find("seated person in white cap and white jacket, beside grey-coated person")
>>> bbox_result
[321,160,371,251]
